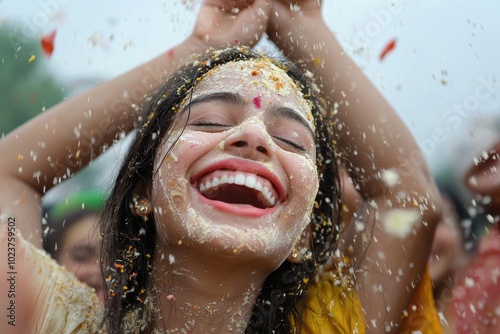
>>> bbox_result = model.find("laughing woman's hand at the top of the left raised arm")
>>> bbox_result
[191,0,272,48]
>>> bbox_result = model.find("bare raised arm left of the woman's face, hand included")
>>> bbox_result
[0,0,270,246]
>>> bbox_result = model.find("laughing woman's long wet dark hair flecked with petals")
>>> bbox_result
[101,47,341,333]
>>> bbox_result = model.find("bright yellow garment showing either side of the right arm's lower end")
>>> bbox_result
[292,264,442,334]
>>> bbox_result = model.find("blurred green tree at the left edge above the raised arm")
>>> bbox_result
[0,25,64,137]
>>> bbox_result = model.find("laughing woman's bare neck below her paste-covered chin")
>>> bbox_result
[153,247,266,333]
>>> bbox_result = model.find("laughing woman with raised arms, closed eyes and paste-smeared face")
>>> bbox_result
[0,0,439,333]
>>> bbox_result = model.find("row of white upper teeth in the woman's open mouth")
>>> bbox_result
[198,172,276,206]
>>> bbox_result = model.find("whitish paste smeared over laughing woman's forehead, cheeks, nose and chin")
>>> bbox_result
[153,61,318,264]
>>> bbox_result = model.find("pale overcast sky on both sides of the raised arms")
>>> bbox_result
[0,0,500,175]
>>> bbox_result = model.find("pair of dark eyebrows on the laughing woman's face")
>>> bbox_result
[183,92,314,138]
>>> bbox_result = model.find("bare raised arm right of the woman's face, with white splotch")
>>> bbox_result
[268,0,440,333]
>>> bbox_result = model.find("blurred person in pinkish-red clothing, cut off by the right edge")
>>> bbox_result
[453,120,500,334]
